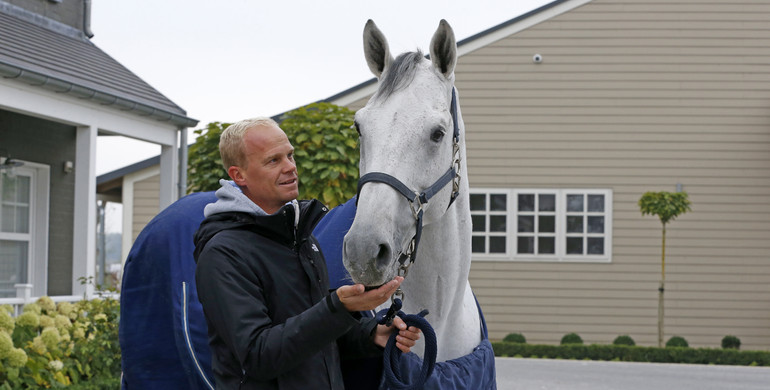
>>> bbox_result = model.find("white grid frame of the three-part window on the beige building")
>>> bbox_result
[470,188,613,263]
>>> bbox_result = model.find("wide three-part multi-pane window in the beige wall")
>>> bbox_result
[470,189,612,261]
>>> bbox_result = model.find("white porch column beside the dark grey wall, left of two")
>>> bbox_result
[72,126,98,298]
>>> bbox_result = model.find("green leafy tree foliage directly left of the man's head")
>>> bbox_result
[187,122,230,193]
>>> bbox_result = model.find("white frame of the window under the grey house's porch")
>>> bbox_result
[0,160,51,296]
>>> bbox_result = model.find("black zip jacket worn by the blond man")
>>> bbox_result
[195,190,381,389]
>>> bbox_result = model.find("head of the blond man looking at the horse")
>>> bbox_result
[228,125,299,214]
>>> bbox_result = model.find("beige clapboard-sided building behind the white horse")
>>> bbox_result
[103,0,770,349]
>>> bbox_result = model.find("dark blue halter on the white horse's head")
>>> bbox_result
[356,87,460,276]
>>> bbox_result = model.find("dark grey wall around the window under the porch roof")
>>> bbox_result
[0,110,75,295]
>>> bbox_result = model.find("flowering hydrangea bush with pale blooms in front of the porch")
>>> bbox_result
[0,297,120,390]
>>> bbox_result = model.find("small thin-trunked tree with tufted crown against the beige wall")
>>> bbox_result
[639,191,691,347]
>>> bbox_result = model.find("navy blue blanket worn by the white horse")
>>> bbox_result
[119,192,496,390]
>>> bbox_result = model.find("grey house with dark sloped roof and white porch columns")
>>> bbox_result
[0,0,197,303]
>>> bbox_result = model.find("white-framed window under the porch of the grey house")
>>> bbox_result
[0,163,49,298]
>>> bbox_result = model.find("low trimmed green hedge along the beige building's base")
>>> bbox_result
[492,341,770,366]
